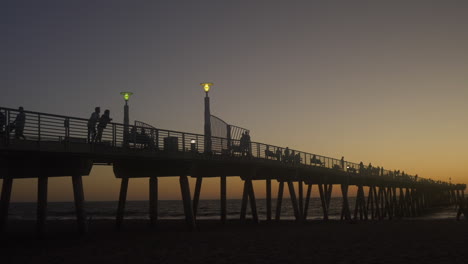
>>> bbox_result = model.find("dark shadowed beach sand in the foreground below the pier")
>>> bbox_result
[0,220,468,264]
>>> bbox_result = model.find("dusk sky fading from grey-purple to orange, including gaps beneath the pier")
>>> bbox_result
[0,0,468,201]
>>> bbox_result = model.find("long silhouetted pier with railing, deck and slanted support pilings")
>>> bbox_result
[0,106,466,233]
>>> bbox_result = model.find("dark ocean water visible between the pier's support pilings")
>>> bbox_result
[9,197,456,220]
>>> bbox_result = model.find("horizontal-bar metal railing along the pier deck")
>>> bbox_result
[0,107,456,185]
